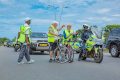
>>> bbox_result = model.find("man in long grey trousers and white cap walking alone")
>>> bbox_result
[18,18,34,64]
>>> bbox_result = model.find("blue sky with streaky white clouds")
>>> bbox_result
[0,0,120,39]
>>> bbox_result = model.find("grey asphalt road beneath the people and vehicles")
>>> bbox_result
[0,47,120,80]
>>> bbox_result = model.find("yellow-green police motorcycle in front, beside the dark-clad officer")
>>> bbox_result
[78,27,103,63]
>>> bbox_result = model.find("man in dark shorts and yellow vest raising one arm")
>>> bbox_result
[48,21,65,62]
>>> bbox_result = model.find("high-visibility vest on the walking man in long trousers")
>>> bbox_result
[18,25,32,43]
